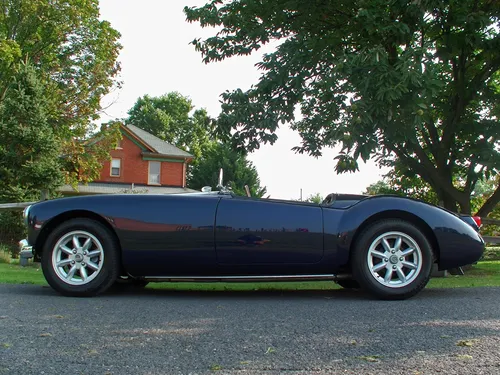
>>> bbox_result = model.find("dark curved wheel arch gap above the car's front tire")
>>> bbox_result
[34,210,121,259]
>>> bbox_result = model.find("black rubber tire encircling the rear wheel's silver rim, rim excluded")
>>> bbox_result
[351,219,434,299]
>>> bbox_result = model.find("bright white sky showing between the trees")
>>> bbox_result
[96,0,384,199]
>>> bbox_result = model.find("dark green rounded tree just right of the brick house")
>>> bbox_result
[187,142,266,198]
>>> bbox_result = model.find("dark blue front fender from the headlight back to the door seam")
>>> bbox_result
[30,195,219,276]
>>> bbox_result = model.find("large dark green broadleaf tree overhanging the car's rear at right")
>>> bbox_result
[185,0,500,216]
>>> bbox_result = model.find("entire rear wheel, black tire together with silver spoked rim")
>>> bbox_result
[351,219,434,300]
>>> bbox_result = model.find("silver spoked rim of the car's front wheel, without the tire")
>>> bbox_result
[52,231,104,285]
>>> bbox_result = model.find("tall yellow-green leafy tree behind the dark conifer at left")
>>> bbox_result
[0,0,121,186]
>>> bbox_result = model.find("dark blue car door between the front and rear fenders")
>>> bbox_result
[215,196,323,266]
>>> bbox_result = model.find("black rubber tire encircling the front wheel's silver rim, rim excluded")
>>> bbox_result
[41,219,119,297]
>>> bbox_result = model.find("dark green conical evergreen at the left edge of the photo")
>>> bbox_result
[0,65,63,256]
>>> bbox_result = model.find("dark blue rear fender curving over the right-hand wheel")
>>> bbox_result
[338,196,484,270]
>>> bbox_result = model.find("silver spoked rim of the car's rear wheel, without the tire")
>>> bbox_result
[366,232,423,288]
